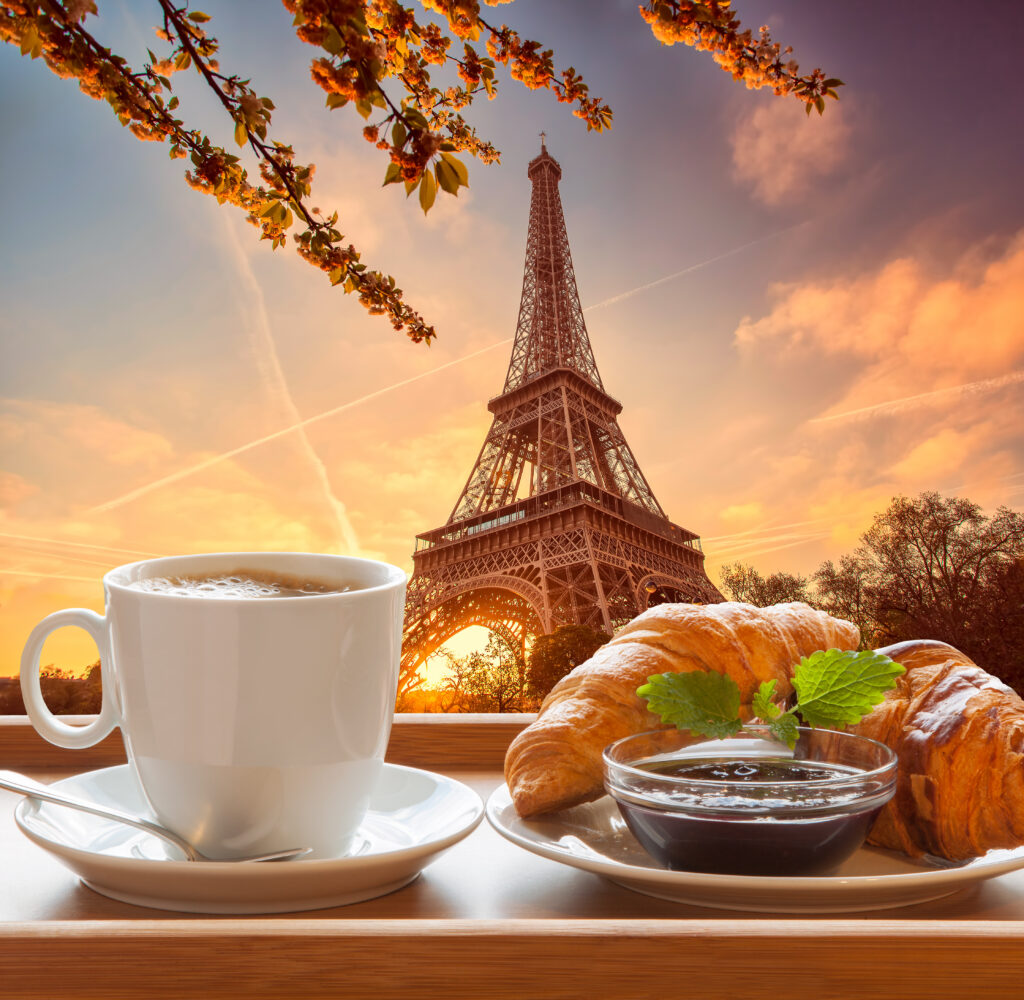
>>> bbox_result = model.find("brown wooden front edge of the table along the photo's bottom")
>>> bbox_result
[0,918,1024,1000]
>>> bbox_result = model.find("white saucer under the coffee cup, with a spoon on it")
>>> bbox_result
[14,764,483,913]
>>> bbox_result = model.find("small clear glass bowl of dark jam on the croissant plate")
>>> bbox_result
[604,726,896,875]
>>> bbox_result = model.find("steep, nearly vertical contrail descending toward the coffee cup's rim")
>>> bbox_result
[223,216,359,553]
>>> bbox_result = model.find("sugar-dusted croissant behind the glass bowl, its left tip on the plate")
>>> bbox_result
[505,602,860,817]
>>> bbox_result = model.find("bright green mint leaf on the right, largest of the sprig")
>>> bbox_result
[793,649,904,729]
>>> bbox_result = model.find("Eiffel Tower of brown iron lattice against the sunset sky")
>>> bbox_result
[402,140,723,677]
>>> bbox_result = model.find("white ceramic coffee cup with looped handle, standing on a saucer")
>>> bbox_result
[20,553,406,858]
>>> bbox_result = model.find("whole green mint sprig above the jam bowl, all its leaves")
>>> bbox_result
[637,649,904,749]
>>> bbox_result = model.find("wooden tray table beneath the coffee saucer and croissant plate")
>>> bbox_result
[0,715,1024,1000]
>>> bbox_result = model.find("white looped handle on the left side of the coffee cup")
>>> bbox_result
[20,608,121,750]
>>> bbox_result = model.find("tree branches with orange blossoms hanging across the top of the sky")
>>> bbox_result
[0,0,842,342]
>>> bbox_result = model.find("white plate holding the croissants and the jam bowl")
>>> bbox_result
[487,785,1024,913]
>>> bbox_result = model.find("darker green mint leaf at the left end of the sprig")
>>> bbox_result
[637,670,741,739]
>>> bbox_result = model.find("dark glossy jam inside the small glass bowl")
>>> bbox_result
[618,759,882,875]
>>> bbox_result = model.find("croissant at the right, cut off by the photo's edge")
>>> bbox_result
[851,640,1024,861]
